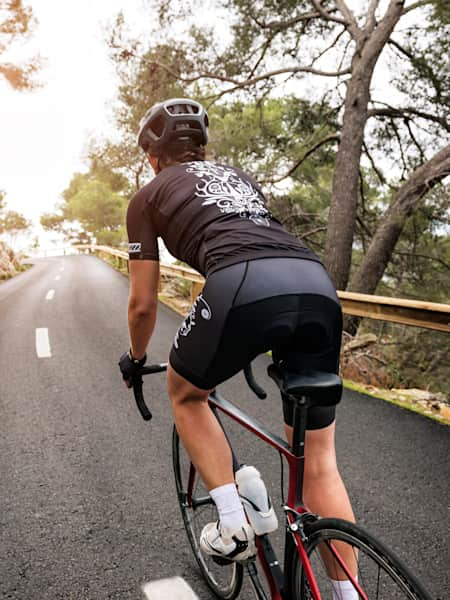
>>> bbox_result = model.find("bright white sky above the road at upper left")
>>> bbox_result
[0,0,150,232]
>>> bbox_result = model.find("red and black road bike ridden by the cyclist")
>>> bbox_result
[134,363,431,600]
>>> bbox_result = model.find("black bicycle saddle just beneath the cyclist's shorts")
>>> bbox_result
[267,364,342,406]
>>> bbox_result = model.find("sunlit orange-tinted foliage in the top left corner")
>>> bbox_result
[0,0,40,90]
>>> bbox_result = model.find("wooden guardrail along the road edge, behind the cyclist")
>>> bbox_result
[74,245,450,332]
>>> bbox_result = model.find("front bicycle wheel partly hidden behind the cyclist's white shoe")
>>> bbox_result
[172,427,244,600]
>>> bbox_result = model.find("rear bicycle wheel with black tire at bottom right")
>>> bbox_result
[287,519,432,600]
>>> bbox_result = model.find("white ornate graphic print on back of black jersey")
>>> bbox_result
[186,160,271,227]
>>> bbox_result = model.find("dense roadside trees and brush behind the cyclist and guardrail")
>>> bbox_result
[42,0,450,392]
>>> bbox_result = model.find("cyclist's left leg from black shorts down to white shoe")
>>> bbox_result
[168,264,256,560]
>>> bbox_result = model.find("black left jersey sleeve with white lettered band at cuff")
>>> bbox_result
[127,190,159,260]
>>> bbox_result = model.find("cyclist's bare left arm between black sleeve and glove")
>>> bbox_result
[128,260,159,358]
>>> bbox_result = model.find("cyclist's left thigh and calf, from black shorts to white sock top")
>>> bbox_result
[168,263,246,489]
